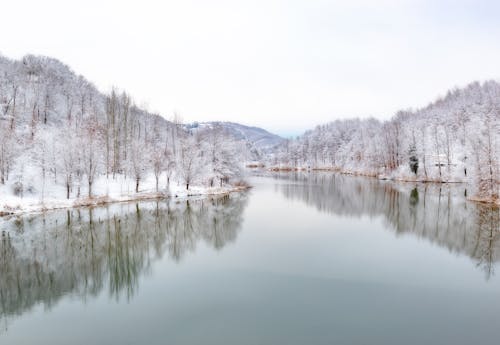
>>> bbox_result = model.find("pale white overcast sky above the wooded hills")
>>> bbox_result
[0,0,500,135]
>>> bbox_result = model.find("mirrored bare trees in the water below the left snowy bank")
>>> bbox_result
[0,194,247,319]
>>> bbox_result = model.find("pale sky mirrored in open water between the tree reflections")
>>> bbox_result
[0,179,500,344]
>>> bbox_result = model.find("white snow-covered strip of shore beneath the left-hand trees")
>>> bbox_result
[0,176,249,216]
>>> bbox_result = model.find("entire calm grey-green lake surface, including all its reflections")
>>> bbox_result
[0,173,500,345]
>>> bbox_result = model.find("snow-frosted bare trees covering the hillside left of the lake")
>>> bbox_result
[0,55,244,198]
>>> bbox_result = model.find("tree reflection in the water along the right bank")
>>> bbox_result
[274,172,500,279]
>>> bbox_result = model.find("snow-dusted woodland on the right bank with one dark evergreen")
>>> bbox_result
[271,81,500,201]
